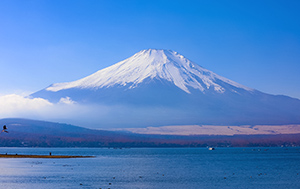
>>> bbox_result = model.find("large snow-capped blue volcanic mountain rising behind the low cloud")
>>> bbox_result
[31,49,300,127]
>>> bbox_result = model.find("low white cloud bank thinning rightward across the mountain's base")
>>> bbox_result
[0,94,206,129]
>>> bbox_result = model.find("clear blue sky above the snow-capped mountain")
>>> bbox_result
[0,0,300,98]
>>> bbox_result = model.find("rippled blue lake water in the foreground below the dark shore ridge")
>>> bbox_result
[0,147,300,189]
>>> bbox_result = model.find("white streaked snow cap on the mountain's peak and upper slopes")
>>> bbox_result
[46,49,253,93]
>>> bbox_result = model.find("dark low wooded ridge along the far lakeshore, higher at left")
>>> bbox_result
[0,118,300,150]
